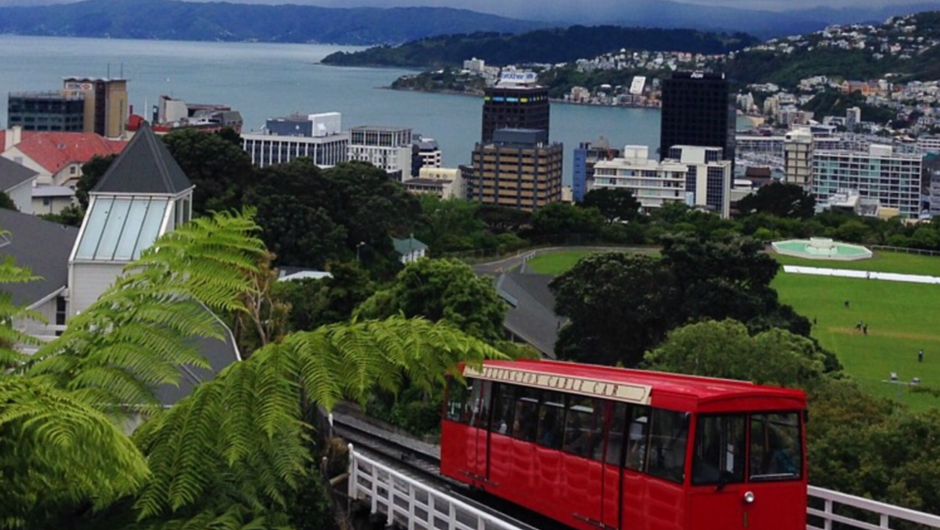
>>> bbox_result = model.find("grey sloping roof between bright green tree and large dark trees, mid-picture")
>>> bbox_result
[496,272,564,359]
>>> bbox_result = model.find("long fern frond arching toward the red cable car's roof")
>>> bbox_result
[135,317,502,522]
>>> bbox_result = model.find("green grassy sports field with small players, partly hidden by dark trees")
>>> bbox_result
[528,251,940,410]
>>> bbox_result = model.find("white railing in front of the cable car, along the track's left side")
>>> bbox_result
[348,444,522,530]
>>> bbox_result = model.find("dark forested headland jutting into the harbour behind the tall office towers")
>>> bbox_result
[323,26,758,67]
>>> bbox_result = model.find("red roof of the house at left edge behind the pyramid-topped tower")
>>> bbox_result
[0,131,127,175]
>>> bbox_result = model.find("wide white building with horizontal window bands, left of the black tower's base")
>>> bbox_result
[594,145,689,213]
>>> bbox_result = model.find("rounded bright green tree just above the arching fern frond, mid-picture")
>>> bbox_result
[357,259,506,342]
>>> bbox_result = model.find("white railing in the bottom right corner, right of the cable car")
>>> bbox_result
[806,486,940,530]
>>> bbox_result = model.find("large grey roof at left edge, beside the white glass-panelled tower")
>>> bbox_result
[0,209,78,306]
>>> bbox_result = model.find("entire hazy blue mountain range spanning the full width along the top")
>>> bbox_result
[0,0,940,45]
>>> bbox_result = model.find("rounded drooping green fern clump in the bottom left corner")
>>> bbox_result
[0,374,148,528]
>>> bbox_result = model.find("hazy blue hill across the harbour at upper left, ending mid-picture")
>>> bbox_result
[0,0,546,45]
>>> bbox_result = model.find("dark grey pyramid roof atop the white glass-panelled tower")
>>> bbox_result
[92,122,193,195]
